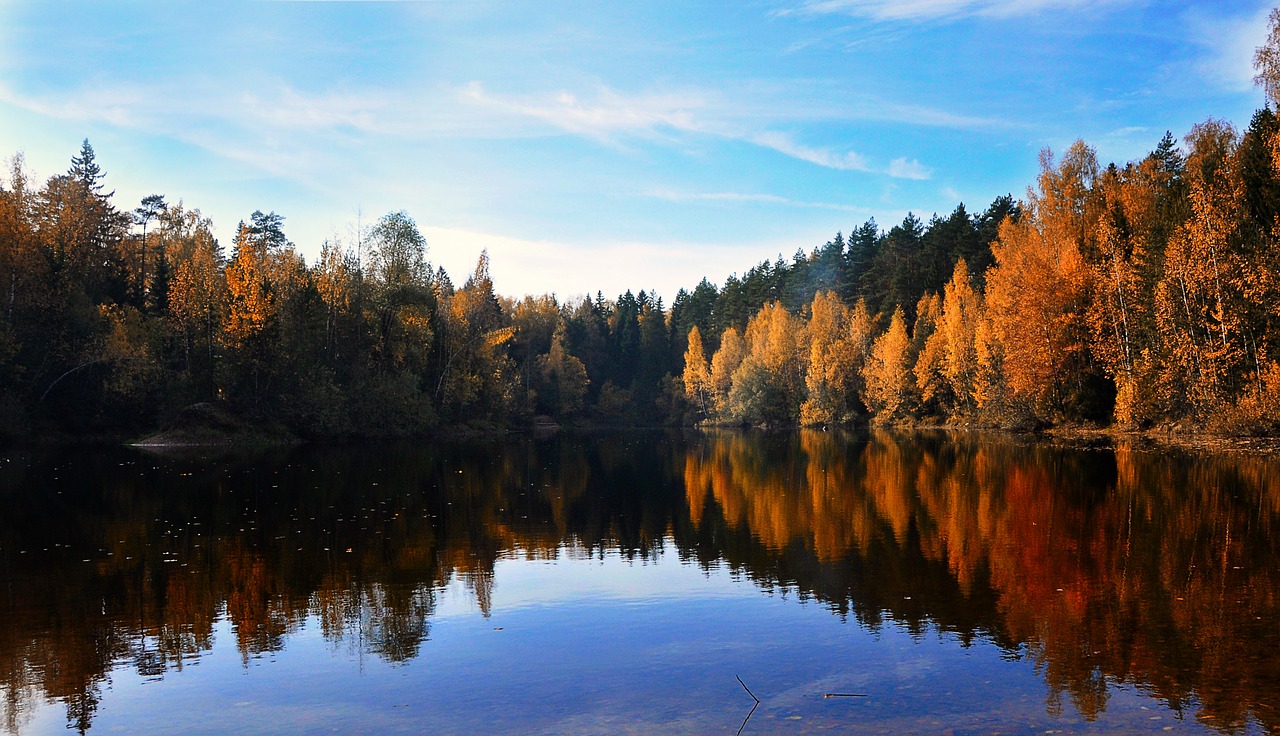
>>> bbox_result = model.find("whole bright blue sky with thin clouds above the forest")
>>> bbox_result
[0,0,1270,300]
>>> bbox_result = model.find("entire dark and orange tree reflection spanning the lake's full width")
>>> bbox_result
[0,431,1280,731]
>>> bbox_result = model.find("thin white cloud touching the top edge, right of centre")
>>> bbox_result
[782,0,1135,20]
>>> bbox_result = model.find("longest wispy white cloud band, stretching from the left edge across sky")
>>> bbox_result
[0,72,942,184]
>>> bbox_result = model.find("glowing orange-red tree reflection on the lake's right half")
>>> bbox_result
[685,431,1280,731]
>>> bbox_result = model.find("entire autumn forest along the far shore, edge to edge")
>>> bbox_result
[12,106,1280,443]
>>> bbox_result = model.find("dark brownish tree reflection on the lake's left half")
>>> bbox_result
[0,439,678,732]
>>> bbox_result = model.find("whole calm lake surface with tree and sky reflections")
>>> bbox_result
[0,431,1280,735]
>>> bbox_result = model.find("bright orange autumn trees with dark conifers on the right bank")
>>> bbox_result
[682,117,1280,434]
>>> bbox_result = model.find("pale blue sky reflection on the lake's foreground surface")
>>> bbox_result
[23,541,1257,735]
